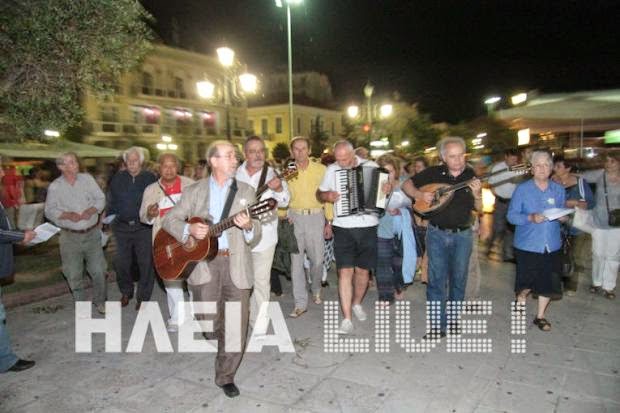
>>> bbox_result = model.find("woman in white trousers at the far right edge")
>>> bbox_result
[590,153,620,300]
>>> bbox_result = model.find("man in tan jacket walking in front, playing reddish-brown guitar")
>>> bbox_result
[162,141,261,397]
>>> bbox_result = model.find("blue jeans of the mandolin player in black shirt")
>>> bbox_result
[426,225,472,331]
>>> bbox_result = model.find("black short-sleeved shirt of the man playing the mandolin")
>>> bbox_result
[411,165,476,229]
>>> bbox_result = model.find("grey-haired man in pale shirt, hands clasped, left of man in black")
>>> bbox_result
[45,152,107,314]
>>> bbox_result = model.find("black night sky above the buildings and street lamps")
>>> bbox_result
[142,0,620,122]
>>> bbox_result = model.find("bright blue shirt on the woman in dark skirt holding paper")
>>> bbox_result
[507,179,565,254]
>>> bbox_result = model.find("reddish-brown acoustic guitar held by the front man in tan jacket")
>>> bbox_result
[153,198,278,281]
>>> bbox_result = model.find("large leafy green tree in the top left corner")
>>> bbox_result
[0,0,152,136]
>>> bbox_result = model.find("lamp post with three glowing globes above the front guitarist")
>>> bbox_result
[196,47,258,141]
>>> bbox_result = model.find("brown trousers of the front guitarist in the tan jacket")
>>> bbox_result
[190,256,250,386]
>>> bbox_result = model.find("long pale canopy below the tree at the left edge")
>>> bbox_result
[0,141,121,159]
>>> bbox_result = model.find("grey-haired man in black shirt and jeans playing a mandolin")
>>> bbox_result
[402,137,482,338]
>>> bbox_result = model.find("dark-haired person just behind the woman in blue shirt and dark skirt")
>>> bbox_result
[551,155,594,296]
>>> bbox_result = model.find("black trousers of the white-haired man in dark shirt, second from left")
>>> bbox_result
[112,223,155,301]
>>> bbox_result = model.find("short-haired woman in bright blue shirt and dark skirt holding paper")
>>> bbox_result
[507,151,566,331]
